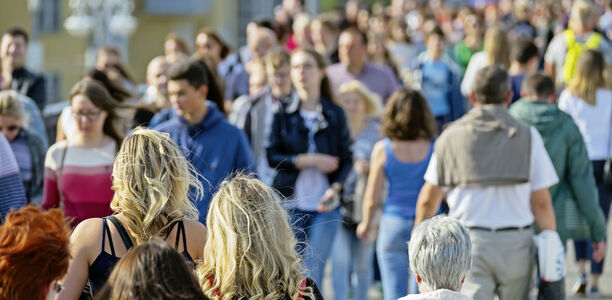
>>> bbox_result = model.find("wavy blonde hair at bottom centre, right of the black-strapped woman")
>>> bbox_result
[197,175,314,300]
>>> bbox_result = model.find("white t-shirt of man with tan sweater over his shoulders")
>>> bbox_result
[425,127,559,228]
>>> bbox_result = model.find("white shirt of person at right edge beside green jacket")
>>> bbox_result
[559,89,612,160]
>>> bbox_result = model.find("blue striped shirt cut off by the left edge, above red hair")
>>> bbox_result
[0,134,27,220]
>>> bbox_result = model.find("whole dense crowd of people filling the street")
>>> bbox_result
[0,0,612,300]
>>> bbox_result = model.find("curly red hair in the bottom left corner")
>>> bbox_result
[0,206,70,299]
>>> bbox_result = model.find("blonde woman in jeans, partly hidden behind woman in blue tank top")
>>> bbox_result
[332,80,382,300]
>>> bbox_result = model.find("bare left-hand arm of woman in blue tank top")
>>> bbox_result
[357,141,387,240]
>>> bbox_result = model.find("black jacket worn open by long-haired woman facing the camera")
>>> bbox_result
[267,96,353,198]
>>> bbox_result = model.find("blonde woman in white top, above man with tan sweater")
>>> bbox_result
[461,25,510,97]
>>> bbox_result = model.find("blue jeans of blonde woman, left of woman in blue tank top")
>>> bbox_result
[332,226,374,300]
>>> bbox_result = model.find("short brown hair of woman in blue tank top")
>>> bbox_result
[381,88,436,140]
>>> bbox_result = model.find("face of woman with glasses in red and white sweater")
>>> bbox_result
[71,95,107,135]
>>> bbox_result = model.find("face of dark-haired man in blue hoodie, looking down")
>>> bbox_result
[168,79,207,116]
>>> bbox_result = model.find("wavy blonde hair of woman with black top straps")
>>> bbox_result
[111,128,202,245]
